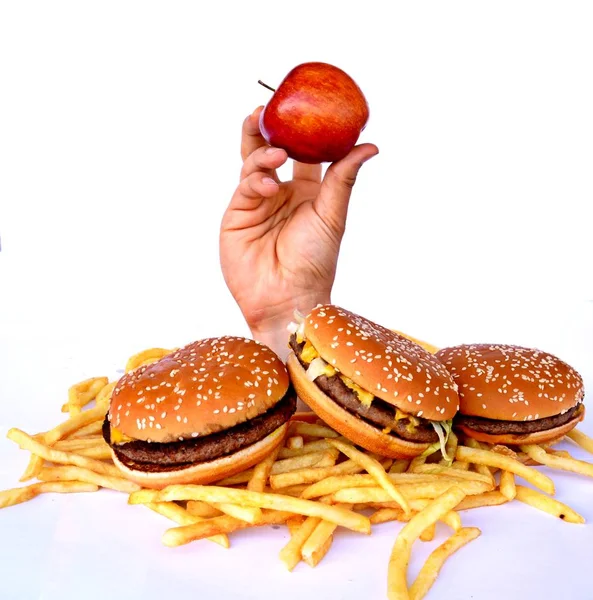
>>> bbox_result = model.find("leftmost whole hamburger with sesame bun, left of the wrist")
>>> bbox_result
[103,337,296,488]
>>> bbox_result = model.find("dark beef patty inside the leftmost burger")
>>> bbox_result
[103,387,296,473]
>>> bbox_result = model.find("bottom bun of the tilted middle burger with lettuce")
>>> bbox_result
[286,353,428,458]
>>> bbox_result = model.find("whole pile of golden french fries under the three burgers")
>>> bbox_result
[0,348,593,600]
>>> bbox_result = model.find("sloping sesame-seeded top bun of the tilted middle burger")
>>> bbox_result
[305,305,459,421]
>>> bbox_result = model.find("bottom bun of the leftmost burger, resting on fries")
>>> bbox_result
[111,423,288,490]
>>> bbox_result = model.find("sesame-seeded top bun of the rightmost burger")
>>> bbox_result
[436,344,585,421]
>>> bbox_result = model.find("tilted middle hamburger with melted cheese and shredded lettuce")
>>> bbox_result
[287,305,459,458]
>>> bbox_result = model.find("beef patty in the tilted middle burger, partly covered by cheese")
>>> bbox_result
[290,334,439,444]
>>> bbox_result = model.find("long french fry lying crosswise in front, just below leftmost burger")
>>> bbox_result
[128,485,371,534]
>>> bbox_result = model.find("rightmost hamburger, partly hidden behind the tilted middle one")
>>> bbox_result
[436,344,585,445]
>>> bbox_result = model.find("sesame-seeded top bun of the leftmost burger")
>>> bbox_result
[109,337,289,442]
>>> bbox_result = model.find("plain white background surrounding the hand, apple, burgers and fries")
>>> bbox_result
[0,0,593,599]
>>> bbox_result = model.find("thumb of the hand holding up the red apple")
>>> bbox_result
[313,144,379,239]
